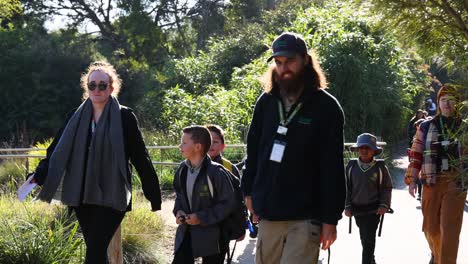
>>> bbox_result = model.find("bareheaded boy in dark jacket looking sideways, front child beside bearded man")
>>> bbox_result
[172,126,236,264]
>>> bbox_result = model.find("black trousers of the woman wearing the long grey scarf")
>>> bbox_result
[73,204,125,264]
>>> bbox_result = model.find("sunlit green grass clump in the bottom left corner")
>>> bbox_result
[0,196,84,264]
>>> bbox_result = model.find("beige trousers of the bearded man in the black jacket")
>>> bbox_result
[255,219,321,264]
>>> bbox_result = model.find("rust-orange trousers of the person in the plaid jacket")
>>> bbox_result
[422,174,466,264]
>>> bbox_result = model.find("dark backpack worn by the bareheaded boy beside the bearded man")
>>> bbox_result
[207,164,247,240]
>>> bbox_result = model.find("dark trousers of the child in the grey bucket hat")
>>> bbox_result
[354,213,380,264]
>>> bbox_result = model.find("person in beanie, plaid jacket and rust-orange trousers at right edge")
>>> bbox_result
[405,85,468,264]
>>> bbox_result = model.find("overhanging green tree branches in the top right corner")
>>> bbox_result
[358,0,468,74]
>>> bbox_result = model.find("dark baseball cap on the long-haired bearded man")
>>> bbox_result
[267,32,307,62]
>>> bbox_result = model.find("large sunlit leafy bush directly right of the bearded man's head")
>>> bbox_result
[292,3,425,141]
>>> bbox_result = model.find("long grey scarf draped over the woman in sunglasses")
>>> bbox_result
[38,96,131,211]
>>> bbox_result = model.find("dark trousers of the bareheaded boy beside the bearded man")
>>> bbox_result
[172,229,229,264]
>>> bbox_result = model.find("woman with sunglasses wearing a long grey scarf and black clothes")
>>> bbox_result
[31,62,161,264]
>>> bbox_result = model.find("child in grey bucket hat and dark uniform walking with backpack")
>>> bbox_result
[345,133,392,264]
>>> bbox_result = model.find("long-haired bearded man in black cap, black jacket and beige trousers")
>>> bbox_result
[242,32,346,264]
